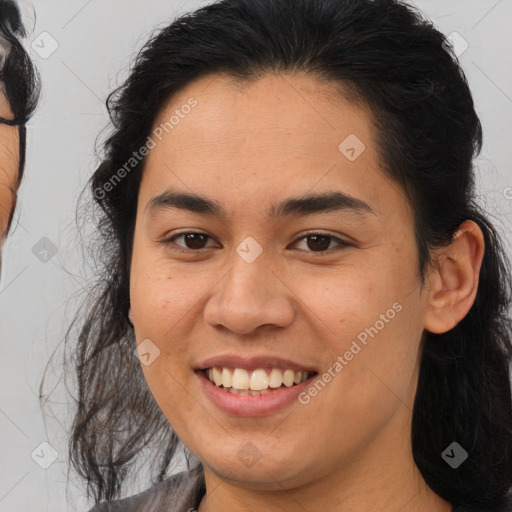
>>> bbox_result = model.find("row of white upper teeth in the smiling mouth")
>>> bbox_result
[206,368,308,391]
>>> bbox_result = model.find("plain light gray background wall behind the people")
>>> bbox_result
[0,0,512,512]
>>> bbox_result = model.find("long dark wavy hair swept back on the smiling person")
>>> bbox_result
[52,0,512,512]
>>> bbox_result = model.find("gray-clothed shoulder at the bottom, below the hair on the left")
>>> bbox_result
[89,470,204,512]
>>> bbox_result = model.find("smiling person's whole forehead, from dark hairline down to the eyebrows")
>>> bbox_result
[141,73,408,222]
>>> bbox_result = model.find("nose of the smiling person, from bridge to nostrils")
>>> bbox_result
[204,248,296,335]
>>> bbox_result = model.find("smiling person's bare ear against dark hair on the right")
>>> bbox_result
[424,220,485,334]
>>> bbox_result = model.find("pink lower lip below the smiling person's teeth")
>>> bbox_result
[195,371,316,416]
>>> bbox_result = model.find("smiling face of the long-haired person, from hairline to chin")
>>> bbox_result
[130,74,427,489]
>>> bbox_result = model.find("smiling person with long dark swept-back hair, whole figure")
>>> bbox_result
[55,0,512,512]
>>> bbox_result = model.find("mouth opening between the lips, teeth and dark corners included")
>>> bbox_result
[203,367,317,396]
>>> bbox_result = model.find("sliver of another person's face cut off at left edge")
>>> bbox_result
[0,92,20,258]
